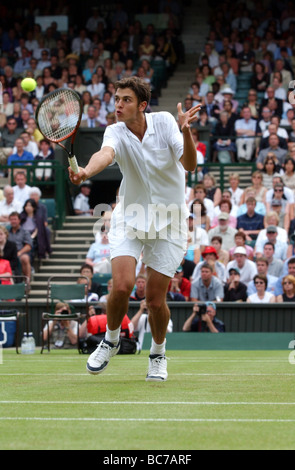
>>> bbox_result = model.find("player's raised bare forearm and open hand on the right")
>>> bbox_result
[177,103,201,171]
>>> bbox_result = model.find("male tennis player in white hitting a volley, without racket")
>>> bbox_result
[69,77,200,381]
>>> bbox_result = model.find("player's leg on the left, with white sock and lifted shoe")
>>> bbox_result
[86,256,136,374]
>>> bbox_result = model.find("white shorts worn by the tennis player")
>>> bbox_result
[109,220,187,278]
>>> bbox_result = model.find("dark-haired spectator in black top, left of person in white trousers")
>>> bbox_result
[212,111,237,163]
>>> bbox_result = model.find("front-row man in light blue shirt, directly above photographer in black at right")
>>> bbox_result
[190,263,224,302]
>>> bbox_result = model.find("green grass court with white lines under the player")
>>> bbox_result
[0,349,295,450]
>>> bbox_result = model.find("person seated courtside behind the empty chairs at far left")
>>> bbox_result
[42,302,78,349]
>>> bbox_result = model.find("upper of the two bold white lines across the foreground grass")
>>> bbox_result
[0,400,295,406]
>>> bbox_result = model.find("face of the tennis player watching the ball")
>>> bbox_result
[115,88,145,124]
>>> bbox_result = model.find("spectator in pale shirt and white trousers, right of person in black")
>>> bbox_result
[235,107,256,162]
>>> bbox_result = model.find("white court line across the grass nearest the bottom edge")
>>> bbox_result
[0,416,295,423]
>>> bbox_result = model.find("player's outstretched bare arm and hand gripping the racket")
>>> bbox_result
[68,146,115,185]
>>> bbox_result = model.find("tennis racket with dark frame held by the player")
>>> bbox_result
[35,88,82,173]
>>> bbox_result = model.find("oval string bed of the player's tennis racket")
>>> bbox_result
[38,89,80,142]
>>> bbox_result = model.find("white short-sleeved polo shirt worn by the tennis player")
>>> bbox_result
[102,112,188,232]
